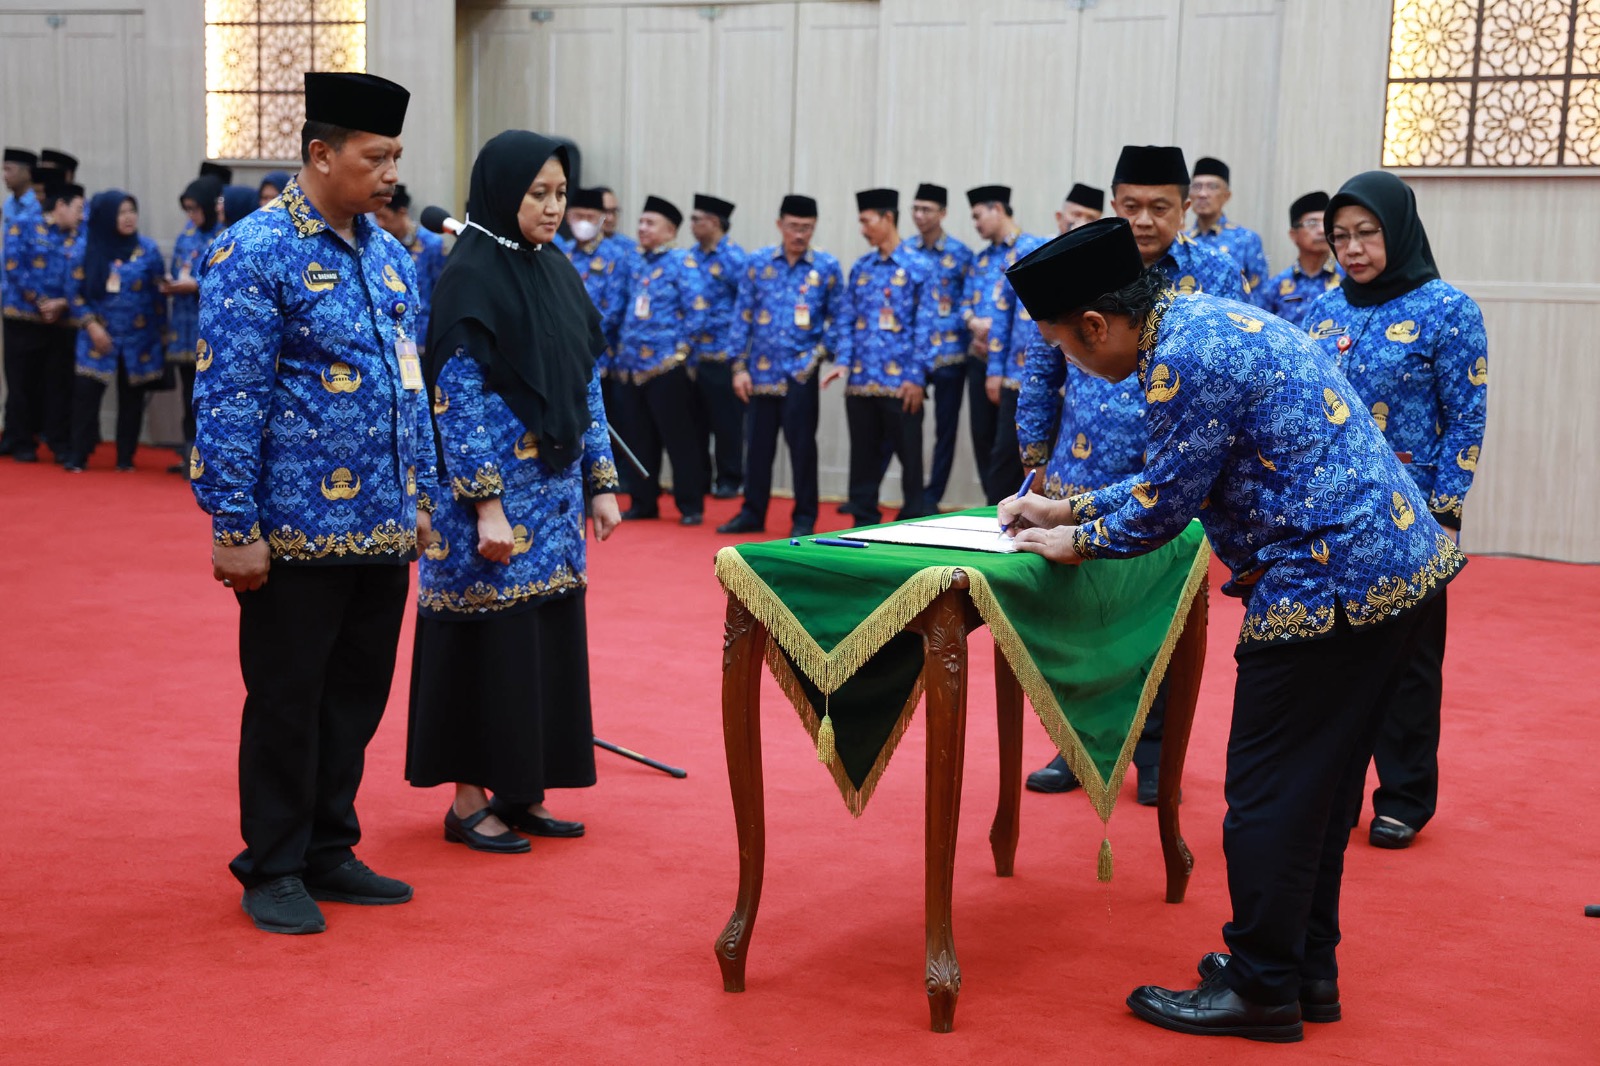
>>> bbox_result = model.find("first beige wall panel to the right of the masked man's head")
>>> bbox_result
[614,6,710,222]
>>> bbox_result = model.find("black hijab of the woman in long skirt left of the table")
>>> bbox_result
[426,130,605,471]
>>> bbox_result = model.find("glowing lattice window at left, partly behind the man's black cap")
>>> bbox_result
[205,0,366,162]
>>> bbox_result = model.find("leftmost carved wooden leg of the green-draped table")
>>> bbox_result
[714,594,768,992]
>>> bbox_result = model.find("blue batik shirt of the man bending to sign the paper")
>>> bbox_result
[1069,296,1466,650]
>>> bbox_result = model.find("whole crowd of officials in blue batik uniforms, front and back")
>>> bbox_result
[3,74,1486,1040]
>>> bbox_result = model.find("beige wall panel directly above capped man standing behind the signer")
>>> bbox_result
[1072,0,1181,187]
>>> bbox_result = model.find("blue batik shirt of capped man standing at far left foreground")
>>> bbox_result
[189,181,435,563]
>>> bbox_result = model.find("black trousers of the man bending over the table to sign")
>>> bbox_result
[1222,595,1442,1004]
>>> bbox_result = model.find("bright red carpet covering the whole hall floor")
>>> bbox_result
[0,451,1600,1066]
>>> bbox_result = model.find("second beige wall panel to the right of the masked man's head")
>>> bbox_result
[707,3,795,224]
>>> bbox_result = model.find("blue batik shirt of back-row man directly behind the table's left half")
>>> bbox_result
[845,242,939,395]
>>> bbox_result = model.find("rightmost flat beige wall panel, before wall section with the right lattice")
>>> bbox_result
[1176,0,1288,243]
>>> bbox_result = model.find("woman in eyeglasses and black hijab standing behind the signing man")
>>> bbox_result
[1306,171,1488,848]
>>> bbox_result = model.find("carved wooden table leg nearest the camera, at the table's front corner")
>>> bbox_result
[920,585,966,1032]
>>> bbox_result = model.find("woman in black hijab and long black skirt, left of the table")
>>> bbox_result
[406,130,621,852]
